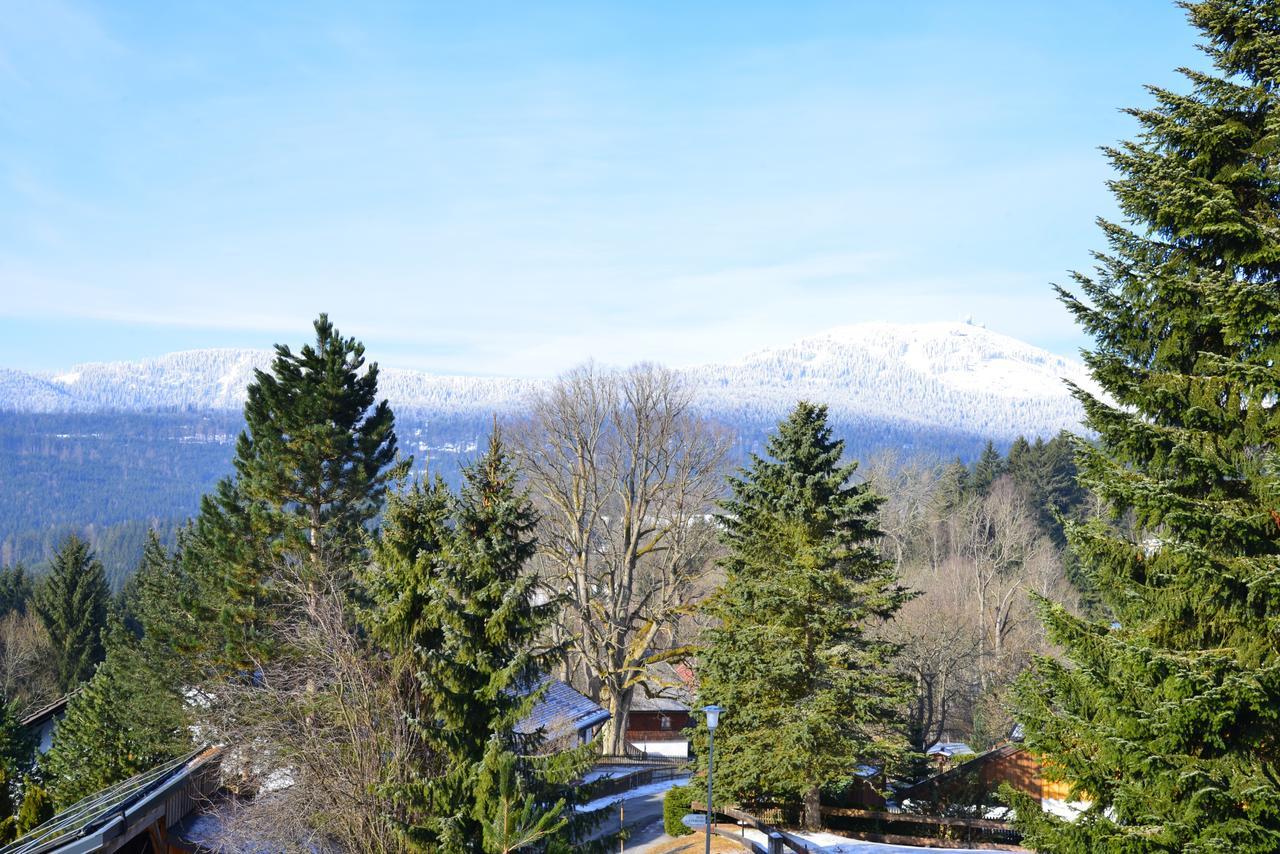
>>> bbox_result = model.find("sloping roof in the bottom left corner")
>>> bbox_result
[0,749,219,854]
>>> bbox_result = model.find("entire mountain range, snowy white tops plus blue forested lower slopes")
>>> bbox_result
[0,323,1089,585]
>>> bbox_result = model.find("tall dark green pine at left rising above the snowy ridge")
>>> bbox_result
[186,314,408,663]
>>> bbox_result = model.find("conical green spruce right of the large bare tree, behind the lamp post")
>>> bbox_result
[699,403,908,827]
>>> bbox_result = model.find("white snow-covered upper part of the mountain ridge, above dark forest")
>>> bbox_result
[0,323,1091,439]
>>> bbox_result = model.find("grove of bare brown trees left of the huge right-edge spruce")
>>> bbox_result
[867,455,1073,750]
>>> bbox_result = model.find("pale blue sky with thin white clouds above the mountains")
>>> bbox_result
[0,0,1202,375]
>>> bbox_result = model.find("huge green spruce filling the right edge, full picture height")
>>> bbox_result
[1018,0,1280,853]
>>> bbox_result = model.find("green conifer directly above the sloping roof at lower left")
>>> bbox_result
[42,625,192,809]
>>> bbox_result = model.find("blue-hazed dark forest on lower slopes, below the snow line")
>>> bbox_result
[0,411,1029,590]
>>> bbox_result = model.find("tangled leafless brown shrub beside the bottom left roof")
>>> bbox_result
[197,576,421,854]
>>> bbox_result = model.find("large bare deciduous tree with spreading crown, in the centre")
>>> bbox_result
[518,365,730,754]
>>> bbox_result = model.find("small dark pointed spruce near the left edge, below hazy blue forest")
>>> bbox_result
[33,534,111,691]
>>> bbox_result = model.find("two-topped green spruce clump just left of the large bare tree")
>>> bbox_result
[370,429,590,851]
